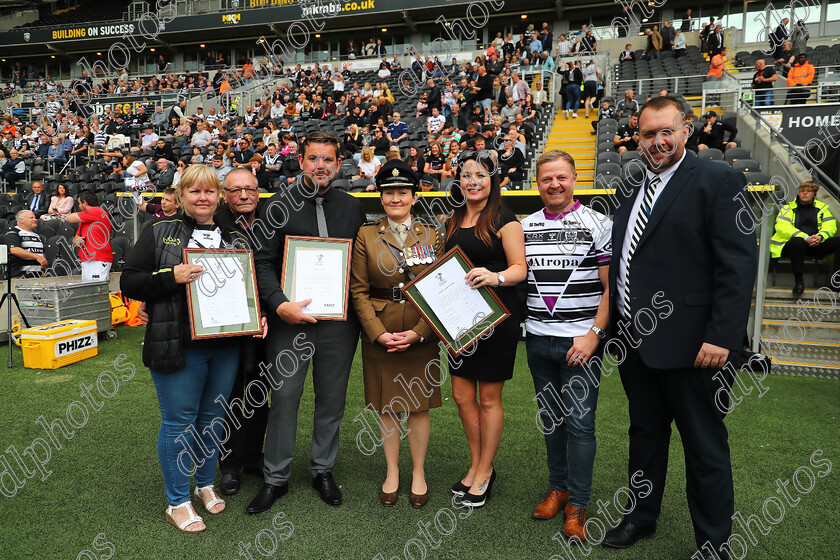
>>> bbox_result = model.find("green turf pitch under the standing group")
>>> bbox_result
[0,327,840,560]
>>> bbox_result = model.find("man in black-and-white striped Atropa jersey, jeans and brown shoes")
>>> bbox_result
[522,150,612,542]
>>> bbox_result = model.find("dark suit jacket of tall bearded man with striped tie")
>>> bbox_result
[610,152,758,369]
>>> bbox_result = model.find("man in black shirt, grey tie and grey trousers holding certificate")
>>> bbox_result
[245,132,367,514]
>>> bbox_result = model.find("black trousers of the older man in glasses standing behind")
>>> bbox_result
[219,337,271,473]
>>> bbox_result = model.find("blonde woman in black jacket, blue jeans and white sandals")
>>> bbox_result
[120,165,266,534]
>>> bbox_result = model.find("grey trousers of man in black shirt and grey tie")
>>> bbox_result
[261,312,359,486]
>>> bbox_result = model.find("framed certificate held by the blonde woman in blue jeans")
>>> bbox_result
[184,249,262,340]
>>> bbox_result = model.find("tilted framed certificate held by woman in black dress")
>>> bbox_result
[403,246,510,356]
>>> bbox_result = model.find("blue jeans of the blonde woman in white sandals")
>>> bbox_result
[149,344,239,506]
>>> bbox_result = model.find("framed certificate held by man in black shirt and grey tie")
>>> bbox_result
[280,235,352,321]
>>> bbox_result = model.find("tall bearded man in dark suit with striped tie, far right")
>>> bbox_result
[603,96,758,559]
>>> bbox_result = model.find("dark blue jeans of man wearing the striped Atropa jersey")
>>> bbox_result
[525,334,601,509]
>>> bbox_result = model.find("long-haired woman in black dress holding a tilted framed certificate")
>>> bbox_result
[446,150,526,507]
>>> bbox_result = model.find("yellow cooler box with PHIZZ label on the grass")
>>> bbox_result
[20,319,99,369]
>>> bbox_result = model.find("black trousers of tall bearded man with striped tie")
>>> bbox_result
[619,344,735,557]
